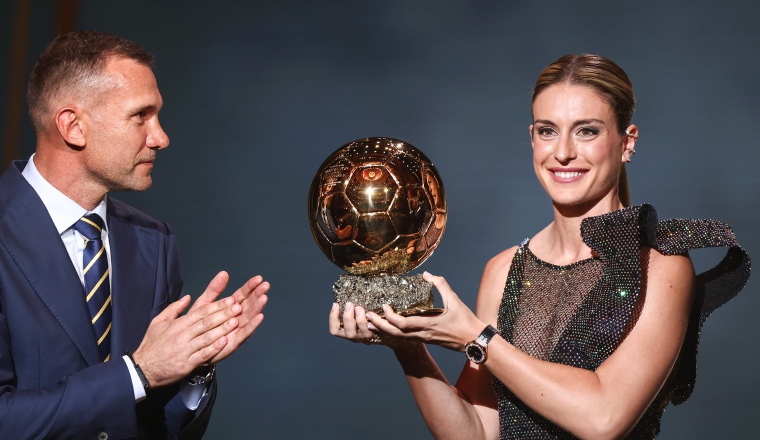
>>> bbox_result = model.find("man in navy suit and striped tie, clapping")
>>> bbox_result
[0,31,269,439]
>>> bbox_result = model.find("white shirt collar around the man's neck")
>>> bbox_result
[21,154,108,235]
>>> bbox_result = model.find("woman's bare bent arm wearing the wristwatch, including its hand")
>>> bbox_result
[370,250,694,438]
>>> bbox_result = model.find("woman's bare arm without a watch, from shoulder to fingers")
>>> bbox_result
[330,248,517,439]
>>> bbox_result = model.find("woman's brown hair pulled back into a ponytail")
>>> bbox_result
[533,54,636,206]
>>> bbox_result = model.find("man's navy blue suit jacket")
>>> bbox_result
[0,162,216,439]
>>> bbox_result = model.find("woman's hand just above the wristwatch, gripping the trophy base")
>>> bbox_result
[360,272,486,351]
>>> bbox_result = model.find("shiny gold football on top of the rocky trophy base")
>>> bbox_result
[309,137,446,275]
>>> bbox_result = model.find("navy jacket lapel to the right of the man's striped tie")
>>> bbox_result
[108,203,160,358]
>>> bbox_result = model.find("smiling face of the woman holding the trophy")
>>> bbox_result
[530,84,637,213]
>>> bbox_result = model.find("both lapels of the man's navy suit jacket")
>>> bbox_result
[0,162,161,365]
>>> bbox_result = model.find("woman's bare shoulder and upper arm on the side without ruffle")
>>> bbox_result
[476,246,518,325]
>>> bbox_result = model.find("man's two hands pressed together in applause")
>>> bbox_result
[132,272,269,387]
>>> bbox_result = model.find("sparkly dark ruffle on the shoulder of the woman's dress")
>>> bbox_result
[581,204,751,404]
